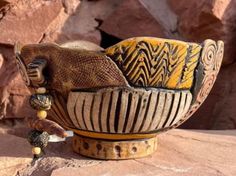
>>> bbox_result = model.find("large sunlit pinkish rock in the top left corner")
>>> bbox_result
[0,0,62,44]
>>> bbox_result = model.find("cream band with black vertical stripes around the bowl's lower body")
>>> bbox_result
[67,88,192,135]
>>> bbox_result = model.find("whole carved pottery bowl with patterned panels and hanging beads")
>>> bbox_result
[15,37,224,159]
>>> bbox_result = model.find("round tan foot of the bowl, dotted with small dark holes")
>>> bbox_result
[73,135,157,160]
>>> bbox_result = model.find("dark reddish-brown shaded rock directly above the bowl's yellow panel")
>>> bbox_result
[100,0,165,39]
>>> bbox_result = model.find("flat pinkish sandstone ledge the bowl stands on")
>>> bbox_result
[0,126,233,176]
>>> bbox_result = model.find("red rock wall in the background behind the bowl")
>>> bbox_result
[0,0,236,129]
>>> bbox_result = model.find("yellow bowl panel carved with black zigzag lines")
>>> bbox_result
[105,37,202,89]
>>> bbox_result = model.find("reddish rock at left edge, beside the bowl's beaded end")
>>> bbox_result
[0,45,34,118]
